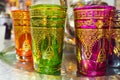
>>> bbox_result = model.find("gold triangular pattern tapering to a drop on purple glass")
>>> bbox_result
[76,29,104,59]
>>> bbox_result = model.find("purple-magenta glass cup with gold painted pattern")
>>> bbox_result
[74,5,115,76]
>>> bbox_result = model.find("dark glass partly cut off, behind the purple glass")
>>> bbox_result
[108,10,120,74]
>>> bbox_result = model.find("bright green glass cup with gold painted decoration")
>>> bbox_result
[30,4,66,75]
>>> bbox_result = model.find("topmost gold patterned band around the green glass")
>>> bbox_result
[31,7,66,18]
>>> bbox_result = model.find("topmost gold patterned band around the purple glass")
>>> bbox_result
[74,9,114,20]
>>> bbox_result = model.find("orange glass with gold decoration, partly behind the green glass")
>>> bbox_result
[12,10,32,61]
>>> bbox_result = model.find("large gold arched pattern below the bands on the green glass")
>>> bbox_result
[32,27,64,60]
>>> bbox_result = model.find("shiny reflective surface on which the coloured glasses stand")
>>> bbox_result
[0,41,120,80]
